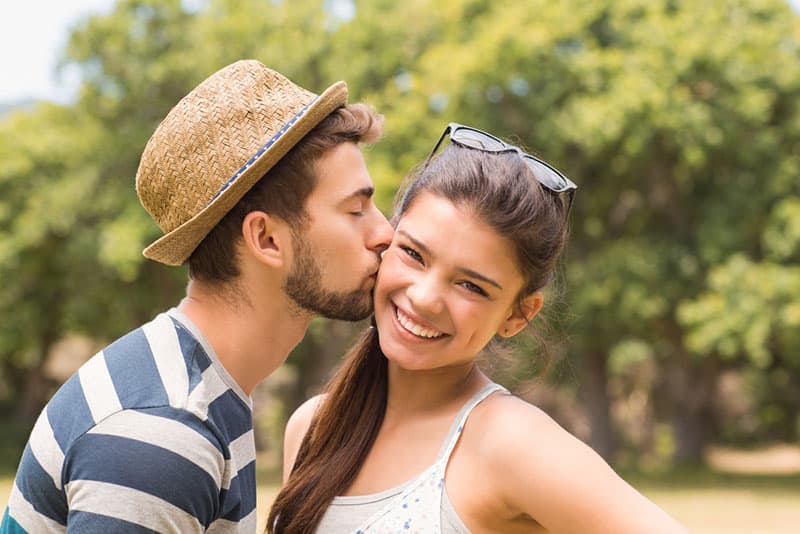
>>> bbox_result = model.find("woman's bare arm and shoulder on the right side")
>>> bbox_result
[487,396,687,534]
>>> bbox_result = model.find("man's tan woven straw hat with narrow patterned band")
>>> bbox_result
[136,60,347,265]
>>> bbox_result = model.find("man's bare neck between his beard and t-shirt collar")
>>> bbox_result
[178,281,311,395]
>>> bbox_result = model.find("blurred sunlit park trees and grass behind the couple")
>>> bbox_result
[0,0,800,532]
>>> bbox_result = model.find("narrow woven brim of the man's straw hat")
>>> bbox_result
[143,82,347,265]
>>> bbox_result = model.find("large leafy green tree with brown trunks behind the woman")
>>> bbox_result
[342,0,800,461]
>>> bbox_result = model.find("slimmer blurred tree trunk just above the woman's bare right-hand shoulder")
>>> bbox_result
[581,351,617,462]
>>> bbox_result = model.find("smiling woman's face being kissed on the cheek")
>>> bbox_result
[375,193,541,370]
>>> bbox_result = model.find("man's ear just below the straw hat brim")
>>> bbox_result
[242,211,292,269]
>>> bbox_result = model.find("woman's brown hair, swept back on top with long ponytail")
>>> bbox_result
[267,140,569,534]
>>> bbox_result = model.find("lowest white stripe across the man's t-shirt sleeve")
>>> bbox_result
[66,480,203,532]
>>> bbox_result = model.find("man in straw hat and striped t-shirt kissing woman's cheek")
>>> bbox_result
[0,61,392,533]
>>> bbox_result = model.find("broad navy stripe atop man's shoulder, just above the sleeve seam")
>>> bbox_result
[103,328,169,408]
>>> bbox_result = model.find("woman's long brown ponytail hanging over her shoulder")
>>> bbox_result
[267,327,388,534]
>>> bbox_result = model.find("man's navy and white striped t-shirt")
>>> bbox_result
[0,309,256,534]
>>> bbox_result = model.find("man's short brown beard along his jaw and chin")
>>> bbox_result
[284,235,372,321]
